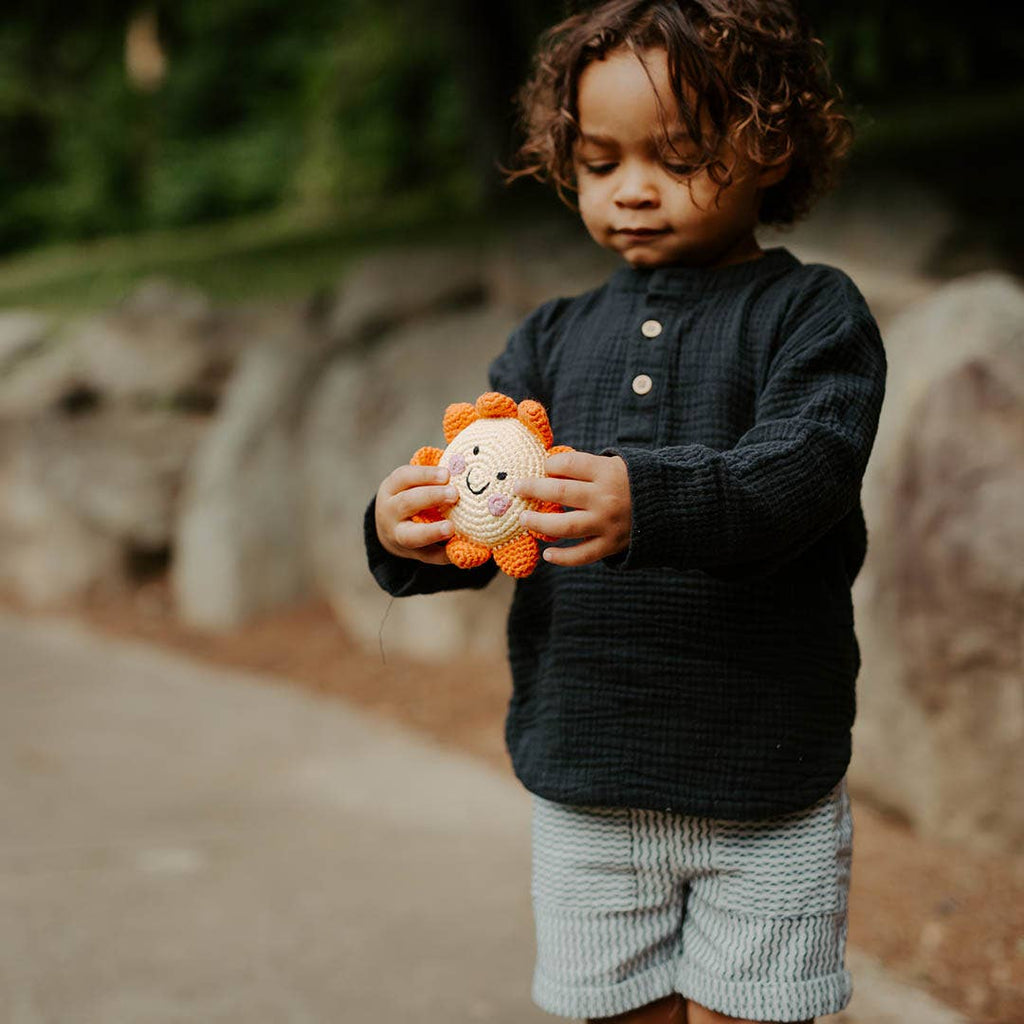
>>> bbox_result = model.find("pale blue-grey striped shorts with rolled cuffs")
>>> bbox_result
[531,779,853,1021]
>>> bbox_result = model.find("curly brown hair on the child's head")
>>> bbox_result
[506,0,853,224]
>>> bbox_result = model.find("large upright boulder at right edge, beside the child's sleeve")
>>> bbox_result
[851,273,1024,849]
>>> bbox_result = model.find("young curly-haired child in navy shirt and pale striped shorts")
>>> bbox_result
[366,0,886,1024]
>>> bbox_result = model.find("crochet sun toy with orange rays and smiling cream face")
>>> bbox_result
[410,391,572,579]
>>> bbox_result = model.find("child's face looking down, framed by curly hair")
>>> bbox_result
[573,49,786,267]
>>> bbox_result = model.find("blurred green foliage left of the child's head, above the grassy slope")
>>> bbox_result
[0,0,487,250]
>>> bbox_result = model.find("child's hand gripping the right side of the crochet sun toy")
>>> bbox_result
[515,452,633,565]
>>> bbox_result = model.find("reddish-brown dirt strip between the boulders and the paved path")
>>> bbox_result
[18,580,1024,1024]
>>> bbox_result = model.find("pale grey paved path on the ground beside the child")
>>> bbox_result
[0,616,961,1024]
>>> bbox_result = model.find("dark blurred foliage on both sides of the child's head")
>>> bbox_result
[0,0,1024,252]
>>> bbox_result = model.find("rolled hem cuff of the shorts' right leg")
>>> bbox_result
[673,959,853,1021]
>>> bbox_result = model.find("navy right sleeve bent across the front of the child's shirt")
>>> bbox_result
[602,310,886,579]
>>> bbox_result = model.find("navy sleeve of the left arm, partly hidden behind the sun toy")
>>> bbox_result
[362,299,563,597]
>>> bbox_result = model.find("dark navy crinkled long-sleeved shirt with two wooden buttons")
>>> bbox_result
[366,248,886,819]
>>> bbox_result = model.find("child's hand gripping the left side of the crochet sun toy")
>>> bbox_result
[375,466,459,565]
